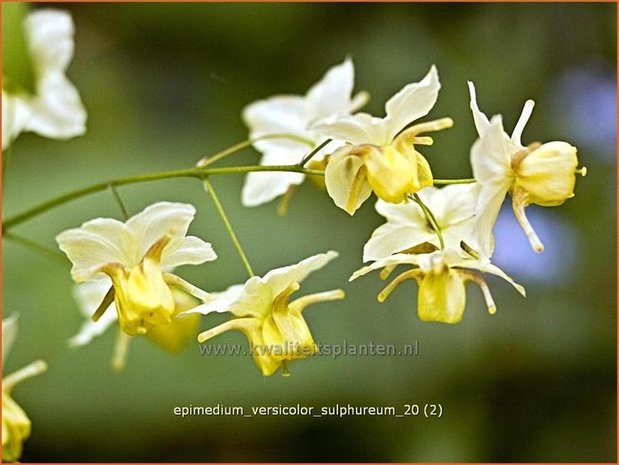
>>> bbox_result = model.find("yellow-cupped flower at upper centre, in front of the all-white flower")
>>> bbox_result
[314,66,453,215]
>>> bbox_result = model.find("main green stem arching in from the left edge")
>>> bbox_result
[2,165,324,234]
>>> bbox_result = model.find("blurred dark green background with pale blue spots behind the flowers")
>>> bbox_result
[2,3,616,462]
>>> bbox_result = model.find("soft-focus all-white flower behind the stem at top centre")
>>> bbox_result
[235,59,367,207]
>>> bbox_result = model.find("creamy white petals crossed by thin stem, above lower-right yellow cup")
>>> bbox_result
[363,183,479,262]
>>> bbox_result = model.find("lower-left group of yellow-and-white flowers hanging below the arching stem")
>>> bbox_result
[57,202,344,376]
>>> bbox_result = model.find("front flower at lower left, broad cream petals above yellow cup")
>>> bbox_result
[56,202,217,335]
